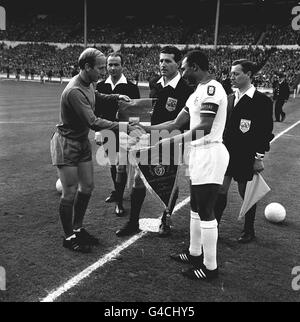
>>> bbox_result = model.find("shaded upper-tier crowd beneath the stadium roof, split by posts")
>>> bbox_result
[0,15,299,45]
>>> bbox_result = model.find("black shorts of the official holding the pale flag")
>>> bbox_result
[225,152,255,182]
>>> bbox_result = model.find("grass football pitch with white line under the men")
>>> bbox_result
[0,81,300,302]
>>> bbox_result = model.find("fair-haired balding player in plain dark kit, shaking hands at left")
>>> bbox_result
[50,48,135,253]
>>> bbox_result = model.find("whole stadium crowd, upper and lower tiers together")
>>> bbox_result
[0,15,300,87]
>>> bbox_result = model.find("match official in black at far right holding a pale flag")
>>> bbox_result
[215,59,274,243]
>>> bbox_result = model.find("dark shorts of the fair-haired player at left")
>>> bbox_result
[50,132,92,167]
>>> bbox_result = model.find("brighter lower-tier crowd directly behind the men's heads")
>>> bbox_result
[0,44,300,88]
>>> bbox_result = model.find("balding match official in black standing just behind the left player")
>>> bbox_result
[95,52,140,217]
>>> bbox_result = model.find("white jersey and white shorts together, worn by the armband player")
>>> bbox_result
[186,80,229,185]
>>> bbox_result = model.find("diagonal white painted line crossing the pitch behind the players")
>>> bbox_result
[40,120,300,302]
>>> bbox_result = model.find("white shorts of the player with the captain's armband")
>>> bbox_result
[189,143,229,185]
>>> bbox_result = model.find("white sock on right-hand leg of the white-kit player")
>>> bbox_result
[201,219,218,270]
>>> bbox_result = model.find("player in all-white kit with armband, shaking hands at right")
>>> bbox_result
[145,50,229,280]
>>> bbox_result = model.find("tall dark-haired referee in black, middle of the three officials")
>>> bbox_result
[116,46,193,237]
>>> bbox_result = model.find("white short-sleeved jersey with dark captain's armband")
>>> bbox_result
[186,79,227,145]
